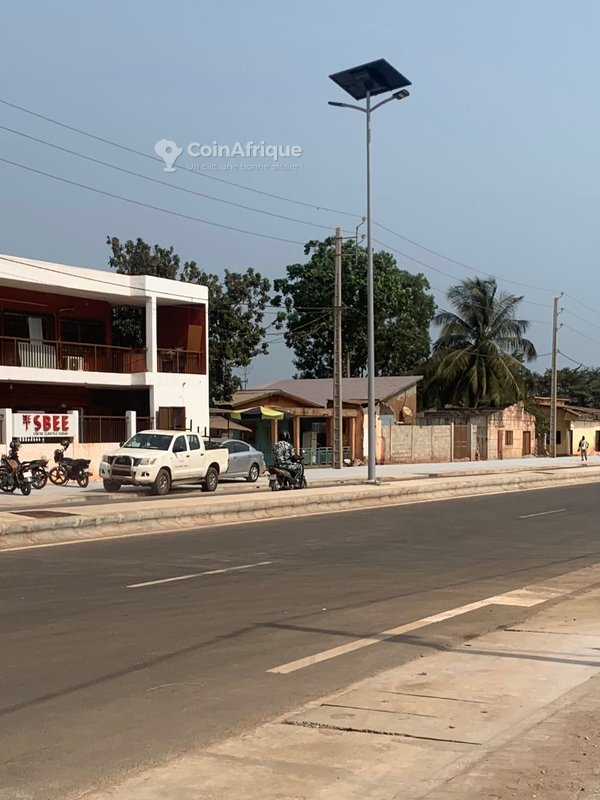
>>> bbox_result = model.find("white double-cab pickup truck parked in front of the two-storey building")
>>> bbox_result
[99,430,229,495]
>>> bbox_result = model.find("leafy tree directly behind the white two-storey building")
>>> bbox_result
[107,237,271,403]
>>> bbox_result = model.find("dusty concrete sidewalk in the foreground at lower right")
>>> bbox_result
[86,565,600,800]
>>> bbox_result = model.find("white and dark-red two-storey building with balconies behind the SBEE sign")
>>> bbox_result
[0,255,209,442]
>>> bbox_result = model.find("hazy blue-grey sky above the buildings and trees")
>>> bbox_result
[0,0,600,386]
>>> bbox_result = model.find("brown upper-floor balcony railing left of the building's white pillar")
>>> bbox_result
[0,336,146,374]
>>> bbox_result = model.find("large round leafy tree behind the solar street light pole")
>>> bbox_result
[273,237,435,378]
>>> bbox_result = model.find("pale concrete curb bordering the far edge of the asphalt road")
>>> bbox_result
[0,469,600,550]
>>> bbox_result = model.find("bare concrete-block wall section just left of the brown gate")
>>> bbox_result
[381,425,452,464]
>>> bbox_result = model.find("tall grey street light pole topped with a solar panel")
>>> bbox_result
[329,58,410,483]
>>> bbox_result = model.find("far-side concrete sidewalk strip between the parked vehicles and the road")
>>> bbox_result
[0,463,600,550]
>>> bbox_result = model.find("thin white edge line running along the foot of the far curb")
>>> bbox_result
[0,479,589,556]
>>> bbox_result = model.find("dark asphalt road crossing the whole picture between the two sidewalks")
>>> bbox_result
[0,484,600,800]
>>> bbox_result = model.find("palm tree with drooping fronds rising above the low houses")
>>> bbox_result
[429,277,536,408]
